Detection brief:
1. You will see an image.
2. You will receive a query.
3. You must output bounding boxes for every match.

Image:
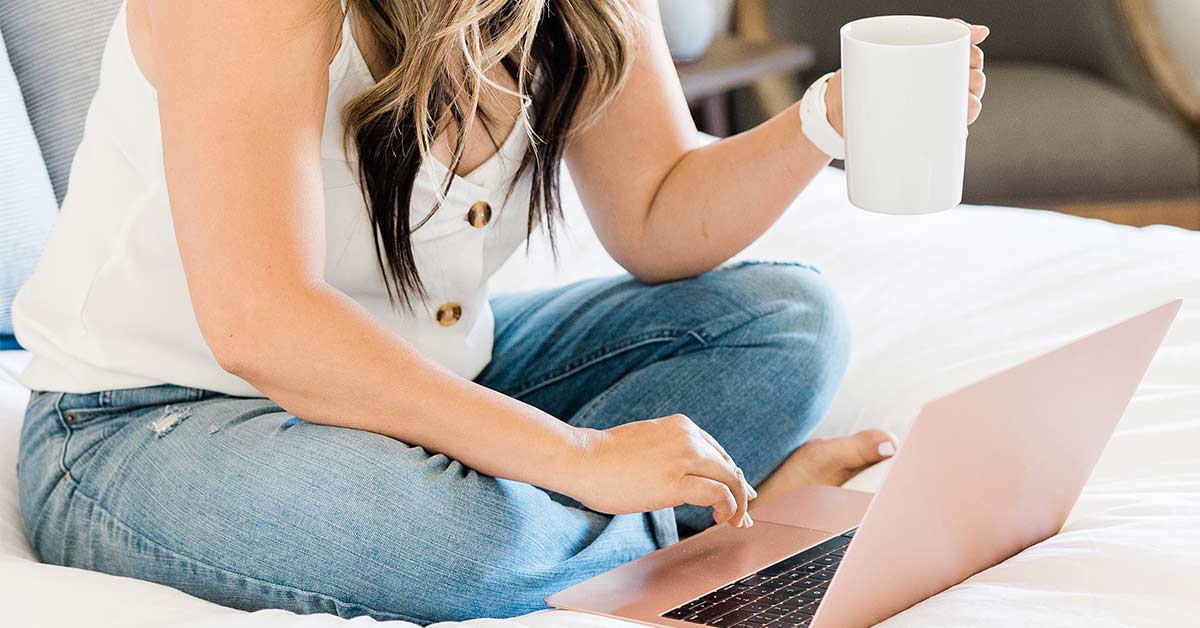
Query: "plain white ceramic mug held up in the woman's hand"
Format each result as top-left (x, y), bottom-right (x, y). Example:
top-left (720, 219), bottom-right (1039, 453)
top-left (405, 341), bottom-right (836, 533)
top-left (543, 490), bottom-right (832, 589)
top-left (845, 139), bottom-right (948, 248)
top-left (841, 16), bottom-right (971, 214)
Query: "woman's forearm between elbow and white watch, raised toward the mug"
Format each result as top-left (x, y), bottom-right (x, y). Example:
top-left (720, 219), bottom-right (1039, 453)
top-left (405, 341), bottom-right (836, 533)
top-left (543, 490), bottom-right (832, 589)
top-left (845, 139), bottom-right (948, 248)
top-left (630, 106), bottom-right (829, 281)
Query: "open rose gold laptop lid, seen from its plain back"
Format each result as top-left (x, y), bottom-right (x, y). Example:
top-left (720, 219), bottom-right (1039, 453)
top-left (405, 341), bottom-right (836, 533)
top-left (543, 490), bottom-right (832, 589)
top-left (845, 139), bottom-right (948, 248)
top-left (812, 300), bottom-right (1182, 628)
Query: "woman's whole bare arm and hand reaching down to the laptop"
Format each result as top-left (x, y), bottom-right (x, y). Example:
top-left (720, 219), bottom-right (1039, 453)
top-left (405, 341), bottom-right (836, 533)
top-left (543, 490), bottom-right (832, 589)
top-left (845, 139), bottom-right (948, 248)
top-left (142, 0), bottom-right (752, 525)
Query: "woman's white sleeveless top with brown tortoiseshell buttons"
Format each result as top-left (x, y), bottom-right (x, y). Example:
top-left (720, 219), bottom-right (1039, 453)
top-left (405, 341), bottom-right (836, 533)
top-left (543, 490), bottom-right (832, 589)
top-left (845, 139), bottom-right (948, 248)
top-left (13, 6), bottom-right (529, 396)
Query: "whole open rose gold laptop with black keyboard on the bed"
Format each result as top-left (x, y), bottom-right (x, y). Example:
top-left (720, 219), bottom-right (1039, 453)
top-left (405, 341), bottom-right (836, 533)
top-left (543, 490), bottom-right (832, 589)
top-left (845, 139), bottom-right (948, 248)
top-left (547, 301), bottom-right (1181, 628)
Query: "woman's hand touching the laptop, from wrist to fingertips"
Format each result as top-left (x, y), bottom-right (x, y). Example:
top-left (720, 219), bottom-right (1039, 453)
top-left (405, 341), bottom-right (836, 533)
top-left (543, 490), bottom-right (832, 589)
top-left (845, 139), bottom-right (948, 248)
top-left (564, 414), bottom-right (757, 527)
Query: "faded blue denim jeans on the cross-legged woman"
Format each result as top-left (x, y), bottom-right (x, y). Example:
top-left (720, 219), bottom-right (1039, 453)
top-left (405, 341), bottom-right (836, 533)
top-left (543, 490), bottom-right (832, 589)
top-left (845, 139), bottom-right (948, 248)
top-left (19, 263), bottom-right (848, 623)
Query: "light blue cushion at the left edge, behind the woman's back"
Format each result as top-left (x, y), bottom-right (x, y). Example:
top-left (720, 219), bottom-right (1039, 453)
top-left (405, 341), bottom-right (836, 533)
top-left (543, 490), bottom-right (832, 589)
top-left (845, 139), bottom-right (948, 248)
top-left (0, 28), bottom-right (58, 348)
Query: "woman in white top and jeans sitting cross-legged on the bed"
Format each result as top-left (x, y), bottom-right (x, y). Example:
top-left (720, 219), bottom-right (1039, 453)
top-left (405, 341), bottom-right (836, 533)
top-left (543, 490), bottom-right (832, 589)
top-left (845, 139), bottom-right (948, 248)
top-left (17, 0), bottom-right (986, 623)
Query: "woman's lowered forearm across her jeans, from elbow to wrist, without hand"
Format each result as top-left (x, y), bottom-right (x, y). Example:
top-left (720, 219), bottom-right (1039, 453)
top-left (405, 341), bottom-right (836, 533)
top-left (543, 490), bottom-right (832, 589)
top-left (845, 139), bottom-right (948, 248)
top-left (222, 285), bottom-right (582, 492)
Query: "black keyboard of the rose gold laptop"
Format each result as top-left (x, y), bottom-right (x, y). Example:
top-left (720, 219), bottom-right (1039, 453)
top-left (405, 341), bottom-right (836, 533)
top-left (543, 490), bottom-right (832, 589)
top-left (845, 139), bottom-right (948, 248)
top-left (662, 528), bottom-right (857, 628)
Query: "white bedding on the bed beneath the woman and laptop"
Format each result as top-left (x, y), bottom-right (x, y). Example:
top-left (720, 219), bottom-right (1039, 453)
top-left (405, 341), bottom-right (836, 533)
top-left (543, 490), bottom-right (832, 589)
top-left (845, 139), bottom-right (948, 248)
top-left (0, 169), bottom-right (1200, 628)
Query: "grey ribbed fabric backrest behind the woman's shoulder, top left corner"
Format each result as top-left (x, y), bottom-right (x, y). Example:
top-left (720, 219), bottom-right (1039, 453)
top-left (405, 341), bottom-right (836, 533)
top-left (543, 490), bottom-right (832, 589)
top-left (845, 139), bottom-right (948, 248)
top-left (0, 0), bottom-right (121, 203)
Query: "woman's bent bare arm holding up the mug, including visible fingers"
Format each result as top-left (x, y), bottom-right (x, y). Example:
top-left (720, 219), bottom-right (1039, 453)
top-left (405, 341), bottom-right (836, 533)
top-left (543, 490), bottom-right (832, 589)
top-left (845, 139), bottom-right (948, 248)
top-left (566, 0), bottom-right (986, 282)
